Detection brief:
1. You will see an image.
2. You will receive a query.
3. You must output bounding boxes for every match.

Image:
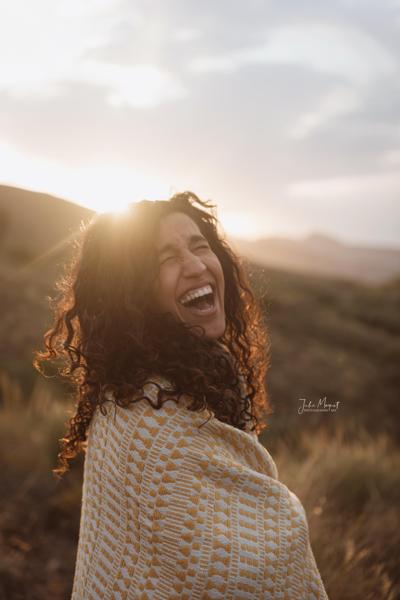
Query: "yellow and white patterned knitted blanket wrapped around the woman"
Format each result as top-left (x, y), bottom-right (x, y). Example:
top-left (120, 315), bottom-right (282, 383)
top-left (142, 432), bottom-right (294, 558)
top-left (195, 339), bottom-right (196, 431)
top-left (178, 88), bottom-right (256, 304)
top-left (71, 378), bottom-right (328, 600)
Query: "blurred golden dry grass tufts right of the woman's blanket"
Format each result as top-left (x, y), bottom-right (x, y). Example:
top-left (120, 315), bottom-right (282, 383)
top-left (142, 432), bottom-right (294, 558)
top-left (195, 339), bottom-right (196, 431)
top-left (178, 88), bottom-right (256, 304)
top-left (276, 430), bottom-right (400, 600)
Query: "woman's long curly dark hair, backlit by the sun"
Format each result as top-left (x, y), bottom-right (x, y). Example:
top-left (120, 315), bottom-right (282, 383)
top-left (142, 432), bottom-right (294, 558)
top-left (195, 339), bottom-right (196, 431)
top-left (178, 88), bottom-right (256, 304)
top-left (33, 191), bottom-right (273, 477)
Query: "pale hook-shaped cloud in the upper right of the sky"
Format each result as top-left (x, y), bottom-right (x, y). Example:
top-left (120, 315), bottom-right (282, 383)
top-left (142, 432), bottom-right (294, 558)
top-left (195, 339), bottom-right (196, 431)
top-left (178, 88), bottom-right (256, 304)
top-left (189, 22), bottom-right (397, 139)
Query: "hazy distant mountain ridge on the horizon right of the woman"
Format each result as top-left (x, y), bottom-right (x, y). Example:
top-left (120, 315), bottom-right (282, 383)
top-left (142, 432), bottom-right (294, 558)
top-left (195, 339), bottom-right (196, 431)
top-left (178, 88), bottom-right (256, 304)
top-left (230, 233), bottom-right (400, 284)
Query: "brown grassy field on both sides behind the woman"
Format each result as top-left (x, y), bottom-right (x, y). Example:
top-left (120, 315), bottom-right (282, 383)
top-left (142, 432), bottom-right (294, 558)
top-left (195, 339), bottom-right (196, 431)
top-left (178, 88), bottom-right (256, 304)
top-left (0, 265), bottom-right (400, 600)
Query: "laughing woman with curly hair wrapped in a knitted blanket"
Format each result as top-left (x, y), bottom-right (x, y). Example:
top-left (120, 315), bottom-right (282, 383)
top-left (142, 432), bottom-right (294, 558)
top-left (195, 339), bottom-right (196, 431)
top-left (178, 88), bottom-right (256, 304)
top-left (35, 192), bottom-right (327, 600)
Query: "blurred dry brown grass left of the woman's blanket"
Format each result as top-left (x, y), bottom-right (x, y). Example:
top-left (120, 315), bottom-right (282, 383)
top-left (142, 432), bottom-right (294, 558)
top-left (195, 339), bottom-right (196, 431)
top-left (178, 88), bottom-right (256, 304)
top-left (0, 372), bottom-right (81, 600)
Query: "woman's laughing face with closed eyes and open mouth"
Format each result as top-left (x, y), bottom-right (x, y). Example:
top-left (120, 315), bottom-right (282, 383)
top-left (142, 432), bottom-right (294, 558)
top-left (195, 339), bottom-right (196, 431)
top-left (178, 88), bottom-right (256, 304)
top-left (154, 212), bottom-right (225, 338)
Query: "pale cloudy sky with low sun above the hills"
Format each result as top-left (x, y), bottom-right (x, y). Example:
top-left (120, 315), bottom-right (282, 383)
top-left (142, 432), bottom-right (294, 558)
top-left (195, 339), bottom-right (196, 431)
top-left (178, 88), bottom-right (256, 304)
top-left (0, 0), bottom-right (400, 247)
